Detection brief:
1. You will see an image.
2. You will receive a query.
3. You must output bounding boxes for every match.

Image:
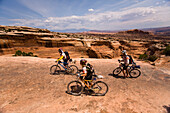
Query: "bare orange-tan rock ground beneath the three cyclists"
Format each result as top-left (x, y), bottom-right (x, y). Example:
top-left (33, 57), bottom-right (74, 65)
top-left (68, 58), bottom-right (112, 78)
top-left (0, 56), bottom-right (170, 113)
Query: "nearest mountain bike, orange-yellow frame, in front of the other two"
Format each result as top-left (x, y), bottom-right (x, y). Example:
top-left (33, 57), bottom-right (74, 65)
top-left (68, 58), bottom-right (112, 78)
top-left (67, 73), bottom-right (108, 96)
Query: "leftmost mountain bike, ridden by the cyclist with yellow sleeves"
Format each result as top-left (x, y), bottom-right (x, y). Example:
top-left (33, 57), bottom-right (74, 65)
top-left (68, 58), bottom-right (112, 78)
top-left (50, 59), bottom-right (78, 75)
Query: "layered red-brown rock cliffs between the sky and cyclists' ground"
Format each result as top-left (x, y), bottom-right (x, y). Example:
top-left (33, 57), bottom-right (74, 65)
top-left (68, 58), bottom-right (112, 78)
top-left (0, 26), bottom-right (169, 58)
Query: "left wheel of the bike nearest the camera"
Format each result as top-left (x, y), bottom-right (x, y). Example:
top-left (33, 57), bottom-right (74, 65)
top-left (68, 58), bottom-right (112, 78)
top-left (67, 81), bottom-right (84, 96)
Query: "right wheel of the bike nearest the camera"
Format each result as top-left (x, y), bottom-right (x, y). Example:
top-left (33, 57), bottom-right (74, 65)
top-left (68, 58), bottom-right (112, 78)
top-left (92, 81), bottom-right (108, 96)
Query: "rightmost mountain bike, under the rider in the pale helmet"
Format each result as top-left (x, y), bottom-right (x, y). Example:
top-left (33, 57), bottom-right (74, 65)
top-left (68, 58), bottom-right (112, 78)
top-left (113, 60), bottom-right (141, 78)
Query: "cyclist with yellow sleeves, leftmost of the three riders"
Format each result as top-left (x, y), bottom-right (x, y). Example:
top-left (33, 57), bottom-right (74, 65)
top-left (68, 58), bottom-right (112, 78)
top-left (56, 49), bottom-right (68, 67)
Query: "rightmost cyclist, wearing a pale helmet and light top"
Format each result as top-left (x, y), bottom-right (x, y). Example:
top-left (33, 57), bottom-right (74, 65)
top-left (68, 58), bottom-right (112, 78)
top-left (118, 50), bottom-right (130, 78)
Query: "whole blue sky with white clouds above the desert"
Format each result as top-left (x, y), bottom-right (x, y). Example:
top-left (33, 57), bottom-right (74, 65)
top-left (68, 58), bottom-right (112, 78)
top-left (0, 0), bottom-right (170, 32)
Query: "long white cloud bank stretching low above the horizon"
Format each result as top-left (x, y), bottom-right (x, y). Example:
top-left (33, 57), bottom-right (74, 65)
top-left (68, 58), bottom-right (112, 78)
top-left (12, 6), bottom-right (170, 30)
